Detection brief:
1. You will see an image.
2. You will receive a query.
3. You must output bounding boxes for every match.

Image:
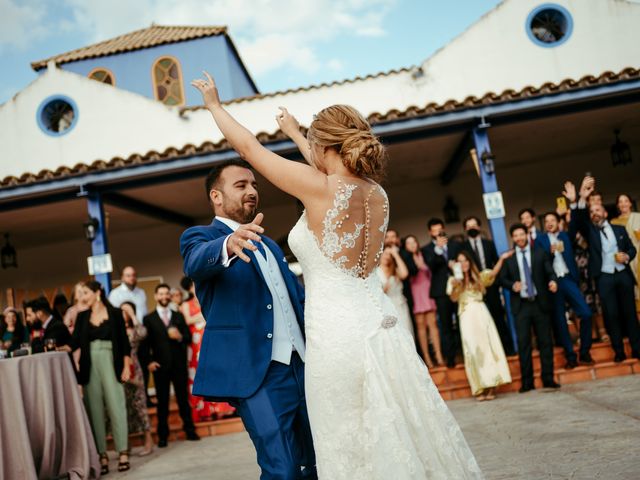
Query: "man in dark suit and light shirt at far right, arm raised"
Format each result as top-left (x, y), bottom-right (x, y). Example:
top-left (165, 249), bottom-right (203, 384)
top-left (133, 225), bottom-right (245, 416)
top-left (563, 177), bottom-right (640, 362)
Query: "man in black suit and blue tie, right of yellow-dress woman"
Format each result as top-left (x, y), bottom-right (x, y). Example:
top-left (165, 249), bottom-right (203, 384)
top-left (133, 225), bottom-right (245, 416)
top-left (500, 223), bottom-right (560, 393)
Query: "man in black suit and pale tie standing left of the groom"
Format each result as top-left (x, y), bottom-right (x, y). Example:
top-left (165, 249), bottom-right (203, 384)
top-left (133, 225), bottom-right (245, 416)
top-left (141, 283), bottom-right (200, 447)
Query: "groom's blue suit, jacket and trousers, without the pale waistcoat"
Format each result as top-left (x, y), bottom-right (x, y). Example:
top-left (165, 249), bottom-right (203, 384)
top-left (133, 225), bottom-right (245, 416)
top-left (180, 220), bottom-right (315, 479)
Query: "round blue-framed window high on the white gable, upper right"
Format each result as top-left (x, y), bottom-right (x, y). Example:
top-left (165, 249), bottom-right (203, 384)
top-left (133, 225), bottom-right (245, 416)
top-left (526, 4), bottom-right (573, 47)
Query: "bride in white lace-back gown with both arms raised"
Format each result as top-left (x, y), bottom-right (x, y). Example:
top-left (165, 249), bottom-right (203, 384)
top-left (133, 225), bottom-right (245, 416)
top-left (192, 72), bottom-right (483, 480)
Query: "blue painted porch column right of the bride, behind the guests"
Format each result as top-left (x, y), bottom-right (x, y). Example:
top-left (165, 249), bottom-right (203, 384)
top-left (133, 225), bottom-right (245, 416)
top-left (473, 124), bottom-right (518, 352)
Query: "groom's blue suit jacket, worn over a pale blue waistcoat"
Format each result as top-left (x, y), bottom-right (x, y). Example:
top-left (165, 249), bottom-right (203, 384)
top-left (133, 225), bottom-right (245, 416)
top-left (180, 220), bottom-right (304, 399)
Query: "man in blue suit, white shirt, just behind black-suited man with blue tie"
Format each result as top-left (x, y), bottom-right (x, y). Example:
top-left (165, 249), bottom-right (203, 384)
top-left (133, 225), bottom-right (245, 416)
top-left (536, 212), bottom-right (593, 368)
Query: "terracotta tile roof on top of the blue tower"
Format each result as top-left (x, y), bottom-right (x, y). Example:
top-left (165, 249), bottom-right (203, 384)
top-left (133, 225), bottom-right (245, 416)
top-left (31, 25), bottom-right (227, 70)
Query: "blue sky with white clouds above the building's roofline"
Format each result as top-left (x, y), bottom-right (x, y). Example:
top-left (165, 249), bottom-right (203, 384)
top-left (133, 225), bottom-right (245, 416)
top-left (0, 0), bottom-right (500, 104)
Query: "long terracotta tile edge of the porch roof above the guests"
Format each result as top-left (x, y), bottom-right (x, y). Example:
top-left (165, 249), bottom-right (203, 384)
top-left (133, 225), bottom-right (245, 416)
top-left (0, 68), bottom-right (640, 188)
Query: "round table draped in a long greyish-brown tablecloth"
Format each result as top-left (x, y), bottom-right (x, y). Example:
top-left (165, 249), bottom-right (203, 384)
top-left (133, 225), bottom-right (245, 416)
top-left (0, 352), bottom-right (100, 480)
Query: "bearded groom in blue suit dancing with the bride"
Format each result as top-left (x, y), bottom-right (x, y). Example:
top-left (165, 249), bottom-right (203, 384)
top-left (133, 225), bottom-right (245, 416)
top-left (180, 160), bottom-right (317, 480)
